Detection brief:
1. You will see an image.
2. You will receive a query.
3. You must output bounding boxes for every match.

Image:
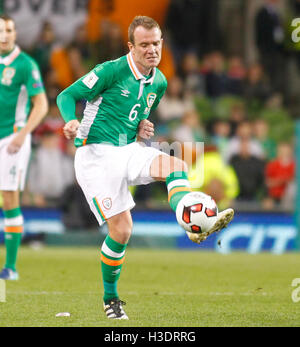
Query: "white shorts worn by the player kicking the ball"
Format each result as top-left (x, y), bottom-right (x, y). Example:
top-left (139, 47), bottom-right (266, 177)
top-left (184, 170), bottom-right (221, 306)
top-left (75, 142), bottom-right (164, 225)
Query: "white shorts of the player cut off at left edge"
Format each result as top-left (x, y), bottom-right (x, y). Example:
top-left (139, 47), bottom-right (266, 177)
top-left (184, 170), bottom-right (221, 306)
top-left (0, 133), bottom-right (31, 191)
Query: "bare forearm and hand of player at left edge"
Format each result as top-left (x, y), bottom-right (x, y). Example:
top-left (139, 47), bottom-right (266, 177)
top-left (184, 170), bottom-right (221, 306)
top-left (7, 93), bottom-right (48, 154)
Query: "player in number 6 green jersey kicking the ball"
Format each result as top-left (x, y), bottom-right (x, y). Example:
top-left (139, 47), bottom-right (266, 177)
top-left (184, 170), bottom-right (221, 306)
top-left (57, 16), bottom-right (233, 319)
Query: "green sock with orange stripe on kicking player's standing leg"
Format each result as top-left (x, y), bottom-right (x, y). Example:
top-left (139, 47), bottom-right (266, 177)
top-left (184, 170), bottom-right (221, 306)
top-left (101, 235), bottom-right (127, 303)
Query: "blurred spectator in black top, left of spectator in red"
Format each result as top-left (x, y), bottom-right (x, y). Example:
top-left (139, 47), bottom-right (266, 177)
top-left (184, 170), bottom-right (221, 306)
top-left (229, 138), bottom-right (265, 203)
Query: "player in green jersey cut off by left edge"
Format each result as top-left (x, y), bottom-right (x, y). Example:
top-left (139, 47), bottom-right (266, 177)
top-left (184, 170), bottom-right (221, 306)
top-left (0, 15), bottom-right (48, 280)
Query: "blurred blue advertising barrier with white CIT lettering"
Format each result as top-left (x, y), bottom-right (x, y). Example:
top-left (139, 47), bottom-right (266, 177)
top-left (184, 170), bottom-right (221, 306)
top-left (0, 208), bottom-right (299, 254)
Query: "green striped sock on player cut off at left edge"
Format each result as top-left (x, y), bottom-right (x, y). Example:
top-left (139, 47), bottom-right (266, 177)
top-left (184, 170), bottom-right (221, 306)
top-left (3, 207), bottom-right (24, 271)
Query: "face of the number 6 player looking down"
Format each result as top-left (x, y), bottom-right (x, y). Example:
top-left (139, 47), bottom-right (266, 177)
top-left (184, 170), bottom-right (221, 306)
top-left (128, 26), bottom-right (163, 75)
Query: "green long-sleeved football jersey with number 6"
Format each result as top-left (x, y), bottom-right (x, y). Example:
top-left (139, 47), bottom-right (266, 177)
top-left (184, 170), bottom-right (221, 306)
top-left (58, 53), bottom-right (167, 147)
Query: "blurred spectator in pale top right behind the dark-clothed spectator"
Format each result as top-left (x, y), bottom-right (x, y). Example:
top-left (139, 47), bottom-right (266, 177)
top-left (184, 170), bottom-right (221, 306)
top-left (225, 121), bottom-right (264, 162)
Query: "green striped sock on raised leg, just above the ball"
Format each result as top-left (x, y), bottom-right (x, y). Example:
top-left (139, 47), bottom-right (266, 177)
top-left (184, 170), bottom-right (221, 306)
top-left (166, 171), bottom-right (191, 212)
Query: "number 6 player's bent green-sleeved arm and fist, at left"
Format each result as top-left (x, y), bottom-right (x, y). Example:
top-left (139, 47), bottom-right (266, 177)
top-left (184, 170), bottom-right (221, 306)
top-left (57, 64), bottom-right (113, 139)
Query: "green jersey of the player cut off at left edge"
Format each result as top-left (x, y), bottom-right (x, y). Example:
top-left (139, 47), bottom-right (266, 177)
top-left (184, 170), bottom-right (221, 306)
top-left (0, 46), bottom-right (44, 139)
